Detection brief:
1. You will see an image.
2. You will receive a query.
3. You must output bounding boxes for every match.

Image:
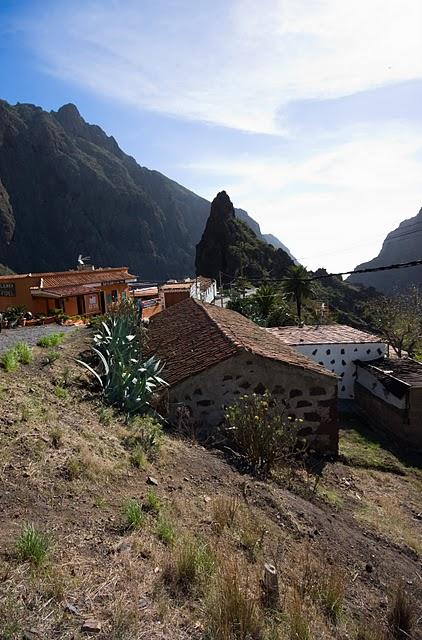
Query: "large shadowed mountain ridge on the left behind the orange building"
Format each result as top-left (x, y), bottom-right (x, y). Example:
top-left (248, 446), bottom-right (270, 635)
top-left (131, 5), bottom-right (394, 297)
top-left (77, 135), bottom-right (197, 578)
top-left (0, 101), bottom-right (286, 279)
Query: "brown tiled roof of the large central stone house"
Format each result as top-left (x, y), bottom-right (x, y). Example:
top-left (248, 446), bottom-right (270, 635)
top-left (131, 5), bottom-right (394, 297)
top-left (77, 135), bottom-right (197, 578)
top-left (148, 298), bottom-right (335, 384)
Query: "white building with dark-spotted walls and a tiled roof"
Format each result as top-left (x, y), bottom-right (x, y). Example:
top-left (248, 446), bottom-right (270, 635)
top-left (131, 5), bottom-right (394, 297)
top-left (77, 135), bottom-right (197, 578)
top-left (268, 324), bottom-right (387, 400)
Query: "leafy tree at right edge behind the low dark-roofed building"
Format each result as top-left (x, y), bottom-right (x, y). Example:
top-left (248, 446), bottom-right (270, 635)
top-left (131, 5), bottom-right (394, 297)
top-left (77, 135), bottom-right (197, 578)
top-left (365, 286), bottom-right (422, 358)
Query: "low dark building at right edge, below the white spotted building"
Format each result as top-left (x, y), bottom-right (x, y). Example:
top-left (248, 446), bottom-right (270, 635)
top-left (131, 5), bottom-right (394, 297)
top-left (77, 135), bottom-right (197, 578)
top-left (355, 358), bottom-right (422, 451)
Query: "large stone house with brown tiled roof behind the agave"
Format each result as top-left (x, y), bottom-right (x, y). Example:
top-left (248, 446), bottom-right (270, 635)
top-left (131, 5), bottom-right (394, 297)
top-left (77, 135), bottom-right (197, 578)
top-left (148, 298), bottom-right (338, 453)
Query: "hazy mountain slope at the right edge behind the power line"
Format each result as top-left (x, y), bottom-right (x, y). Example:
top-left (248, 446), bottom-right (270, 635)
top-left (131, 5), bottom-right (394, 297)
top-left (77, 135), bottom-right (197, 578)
top-left (347, 209), bottom-right (422, 293)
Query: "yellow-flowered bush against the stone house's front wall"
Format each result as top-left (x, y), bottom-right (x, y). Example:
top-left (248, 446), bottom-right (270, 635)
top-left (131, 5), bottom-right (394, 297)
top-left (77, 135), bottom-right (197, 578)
top-left (225, 392), bottom-right (300, 477)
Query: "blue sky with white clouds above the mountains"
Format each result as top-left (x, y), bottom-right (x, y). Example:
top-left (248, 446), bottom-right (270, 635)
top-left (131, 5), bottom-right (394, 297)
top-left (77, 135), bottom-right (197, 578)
top-left (0, 0), bottom-right (422, 271)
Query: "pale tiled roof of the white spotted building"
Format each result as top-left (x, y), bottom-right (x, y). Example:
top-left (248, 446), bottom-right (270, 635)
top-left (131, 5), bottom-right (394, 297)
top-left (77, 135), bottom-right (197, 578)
top-left (267, 324), bottom-right (384, 346)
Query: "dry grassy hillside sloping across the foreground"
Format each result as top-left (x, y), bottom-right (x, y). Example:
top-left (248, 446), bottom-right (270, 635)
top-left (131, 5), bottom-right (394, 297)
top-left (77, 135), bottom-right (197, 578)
top-left (0, 330), bottom-right (422, 640)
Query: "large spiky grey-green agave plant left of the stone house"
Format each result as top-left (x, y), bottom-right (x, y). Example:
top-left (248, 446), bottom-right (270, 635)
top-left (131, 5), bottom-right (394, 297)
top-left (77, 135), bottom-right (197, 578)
top-left (78, 305), bottom-right (167, 415)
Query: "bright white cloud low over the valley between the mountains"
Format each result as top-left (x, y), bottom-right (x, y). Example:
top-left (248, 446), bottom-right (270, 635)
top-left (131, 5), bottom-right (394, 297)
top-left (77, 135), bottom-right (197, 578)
top-left (184, 125), bottom-right (422, 271)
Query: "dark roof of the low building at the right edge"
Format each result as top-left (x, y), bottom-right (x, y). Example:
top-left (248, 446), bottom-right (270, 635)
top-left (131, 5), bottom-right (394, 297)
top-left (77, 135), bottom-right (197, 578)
top-left (357, 358), bottom-right (422, 395)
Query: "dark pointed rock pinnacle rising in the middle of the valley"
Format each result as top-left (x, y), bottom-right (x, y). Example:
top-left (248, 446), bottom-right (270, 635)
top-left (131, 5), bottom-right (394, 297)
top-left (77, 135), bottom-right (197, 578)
top-left (195, 191), bottom-right (292, 281)
